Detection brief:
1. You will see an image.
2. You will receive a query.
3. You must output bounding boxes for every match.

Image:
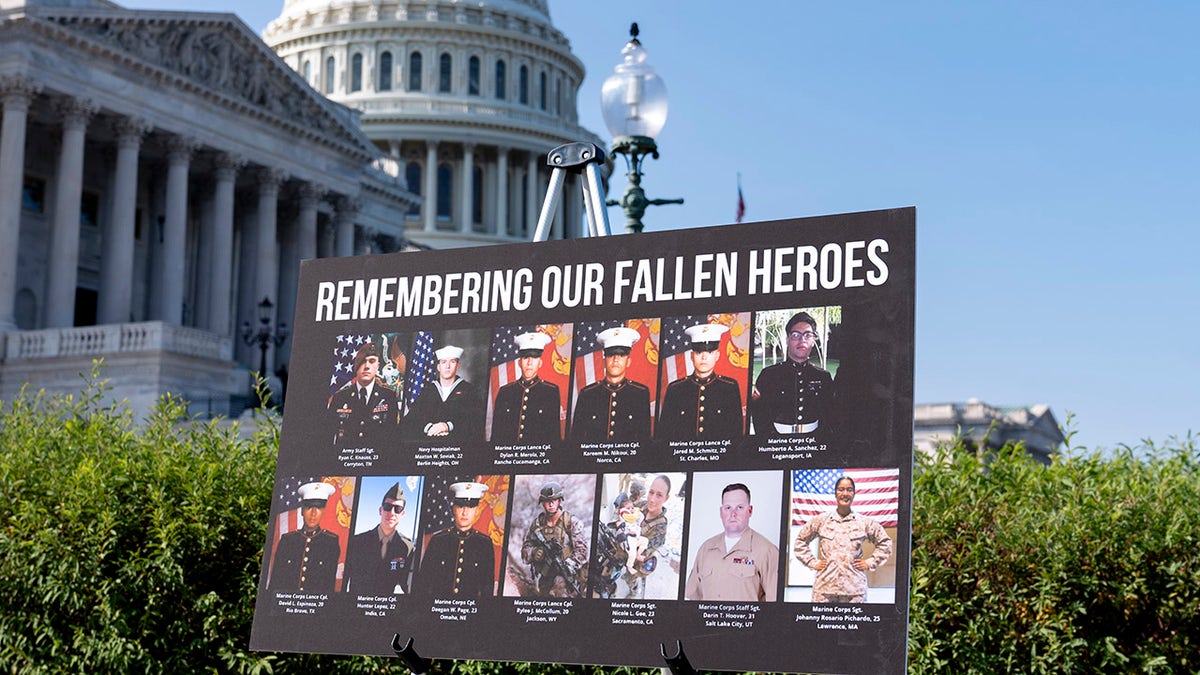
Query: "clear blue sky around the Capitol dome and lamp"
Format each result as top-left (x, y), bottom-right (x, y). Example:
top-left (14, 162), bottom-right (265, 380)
top-left (124, 0), bottom-right (1200, 448)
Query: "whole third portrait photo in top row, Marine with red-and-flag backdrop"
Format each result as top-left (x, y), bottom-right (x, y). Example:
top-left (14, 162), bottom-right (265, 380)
top-left (488, 327), bottom-right (570, 446)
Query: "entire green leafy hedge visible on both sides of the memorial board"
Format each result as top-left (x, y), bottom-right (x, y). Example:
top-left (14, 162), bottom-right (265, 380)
top-left (0, 370), bottom-right (1200, 675)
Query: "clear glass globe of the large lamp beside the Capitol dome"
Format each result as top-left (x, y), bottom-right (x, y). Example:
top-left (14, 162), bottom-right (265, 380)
top-left (600, 34), bottom-right (667, 138)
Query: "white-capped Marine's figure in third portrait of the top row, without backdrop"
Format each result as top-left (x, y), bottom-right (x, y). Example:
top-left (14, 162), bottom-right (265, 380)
top-left (492, 333), bottom-right (563, 444)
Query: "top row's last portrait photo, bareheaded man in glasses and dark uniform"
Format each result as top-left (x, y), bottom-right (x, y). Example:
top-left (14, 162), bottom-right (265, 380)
top-left (750, 307), bottom-right (841, 440)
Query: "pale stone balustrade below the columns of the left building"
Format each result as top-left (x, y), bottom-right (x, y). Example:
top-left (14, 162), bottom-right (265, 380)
top-left (5, 321), bottom-right (233, 360)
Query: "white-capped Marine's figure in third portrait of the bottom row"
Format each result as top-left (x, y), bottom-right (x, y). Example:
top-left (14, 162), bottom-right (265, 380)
top-left (416, 482), bottom-right (496, 598)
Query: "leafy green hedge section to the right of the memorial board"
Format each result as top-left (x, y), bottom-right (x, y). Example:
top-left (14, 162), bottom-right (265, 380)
top-left (908, 437), bottom-right (1200, 673)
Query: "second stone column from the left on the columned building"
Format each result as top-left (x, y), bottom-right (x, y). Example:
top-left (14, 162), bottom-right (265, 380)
top-left (46, 98), bottom-right (96, 328)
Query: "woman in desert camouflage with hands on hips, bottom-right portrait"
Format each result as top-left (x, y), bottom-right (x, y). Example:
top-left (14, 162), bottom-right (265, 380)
top-left (793, 476), bottom-right (892, 603)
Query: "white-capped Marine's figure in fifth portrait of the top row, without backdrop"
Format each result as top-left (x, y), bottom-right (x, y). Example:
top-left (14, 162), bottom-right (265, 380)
top-left (654, 323), bottom-right (742, 441)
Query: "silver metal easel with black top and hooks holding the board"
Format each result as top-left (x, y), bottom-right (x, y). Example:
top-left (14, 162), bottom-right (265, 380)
top-left (391, 143), bottom-right (696, 675)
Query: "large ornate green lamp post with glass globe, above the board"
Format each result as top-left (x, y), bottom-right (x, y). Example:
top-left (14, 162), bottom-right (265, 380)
top-left (600, 23), bottom-right (683, 232)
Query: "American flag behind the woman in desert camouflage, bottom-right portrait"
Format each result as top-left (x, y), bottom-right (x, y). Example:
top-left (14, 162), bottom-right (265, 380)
top-left (792, 468), bottom-right (900, 527)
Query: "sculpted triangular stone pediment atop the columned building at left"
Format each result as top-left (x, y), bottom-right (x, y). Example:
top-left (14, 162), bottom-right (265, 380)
top-left (30, 10), bottom-right (376, 157)
